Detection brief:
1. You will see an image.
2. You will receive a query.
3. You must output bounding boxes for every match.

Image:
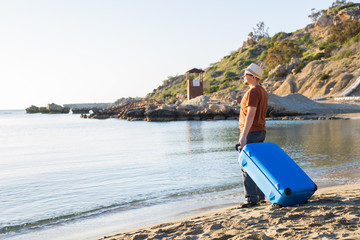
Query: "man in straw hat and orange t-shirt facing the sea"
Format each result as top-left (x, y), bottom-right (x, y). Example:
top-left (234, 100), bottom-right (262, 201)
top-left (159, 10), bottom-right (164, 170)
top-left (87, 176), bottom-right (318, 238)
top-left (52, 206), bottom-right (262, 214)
top-left (238, 63), bottom-right (268, 208)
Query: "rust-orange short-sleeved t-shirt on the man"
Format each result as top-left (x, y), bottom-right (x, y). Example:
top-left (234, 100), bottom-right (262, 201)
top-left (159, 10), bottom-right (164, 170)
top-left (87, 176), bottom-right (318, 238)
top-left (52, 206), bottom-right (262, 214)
top-left (239, 85), bottom-right (269, 132)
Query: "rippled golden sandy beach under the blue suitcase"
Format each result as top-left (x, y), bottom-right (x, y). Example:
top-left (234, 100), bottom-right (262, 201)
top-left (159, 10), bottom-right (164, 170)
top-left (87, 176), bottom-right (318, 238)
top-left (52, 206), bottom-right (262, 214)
top-left (100, 184), bottom-right (360, 240)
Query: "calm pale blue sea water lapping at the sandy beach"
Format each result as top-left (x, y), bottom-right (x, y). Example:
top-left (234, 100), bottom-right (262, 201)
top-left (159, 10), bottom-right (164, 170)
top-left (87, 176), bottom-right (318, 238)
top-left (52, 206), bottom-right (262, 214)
top-left (0, 111), bottom-right (360, 239)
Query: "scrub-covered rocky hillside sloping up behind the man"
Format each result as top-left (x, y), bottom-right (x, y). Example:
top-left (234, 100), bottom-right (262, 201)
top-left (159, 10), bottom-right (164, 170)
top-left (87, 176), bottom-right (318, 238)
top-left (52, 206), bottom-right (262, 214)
top-left (145, 0), bottom-right (360, 103)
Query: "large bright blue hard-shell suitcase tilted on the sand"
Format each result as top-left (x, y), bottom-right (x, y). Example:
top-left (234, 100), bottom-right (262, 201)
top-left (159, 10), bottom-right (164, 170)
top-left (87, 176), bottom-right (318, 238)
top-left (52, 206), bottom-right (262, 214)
top-left (239, 143), bottom-right (317, 206)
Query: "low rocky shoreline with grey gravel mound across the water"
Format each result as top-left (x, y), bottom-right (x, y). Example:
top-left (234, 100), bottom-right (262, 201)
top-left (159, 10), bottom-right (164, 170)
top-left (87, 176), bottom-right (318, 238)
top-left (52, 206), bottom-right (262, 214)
top-left (26, 93), bottom-right (360, 122)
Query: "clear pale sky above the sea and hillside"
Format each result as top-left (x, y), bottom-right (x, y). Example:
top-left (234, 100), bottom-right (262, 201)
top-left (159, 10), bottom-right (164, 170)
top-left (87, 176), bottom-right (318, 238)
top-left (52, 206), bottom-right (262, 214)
top-left (0, 0), bottom-right (348, 109)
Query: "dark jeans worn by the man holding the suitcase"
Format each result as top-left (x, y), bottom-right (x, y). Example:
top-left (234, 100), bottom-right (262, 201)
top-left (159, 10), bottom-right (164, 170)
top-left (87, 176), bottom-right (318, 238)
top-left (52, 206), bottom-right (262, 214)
top-left (241, 131), bottom-right (266, 202)
